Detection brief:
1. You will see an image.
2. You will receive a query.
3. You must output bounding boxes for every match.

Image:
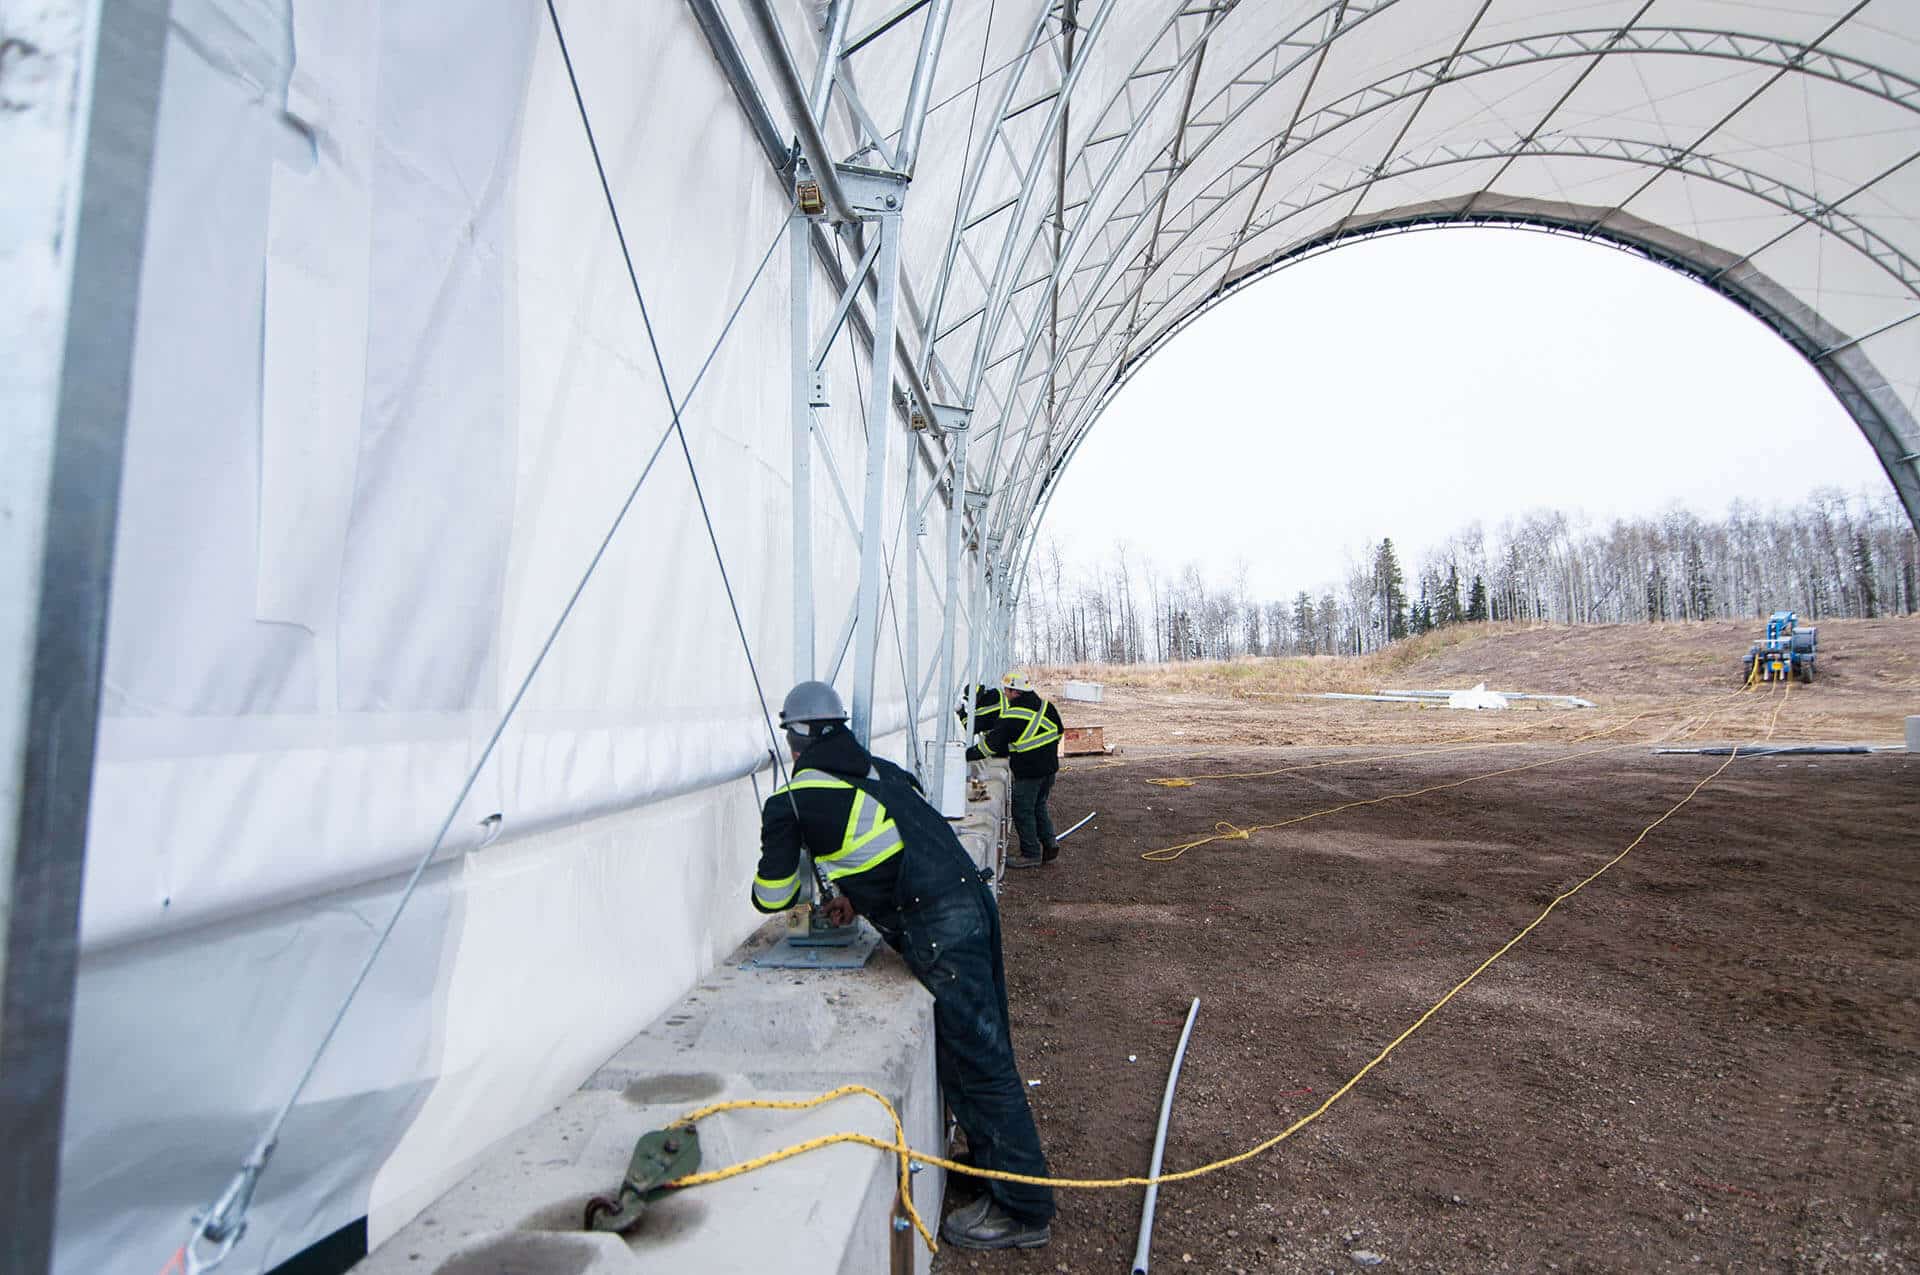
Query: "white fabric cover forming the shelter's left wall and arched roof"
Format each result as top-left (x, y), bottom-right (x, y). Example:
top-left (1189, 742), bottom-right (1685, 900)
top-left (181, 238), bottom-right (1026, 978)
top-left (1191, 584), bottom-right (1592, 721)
top-left (45, 0), bottom-right (1920, 1275)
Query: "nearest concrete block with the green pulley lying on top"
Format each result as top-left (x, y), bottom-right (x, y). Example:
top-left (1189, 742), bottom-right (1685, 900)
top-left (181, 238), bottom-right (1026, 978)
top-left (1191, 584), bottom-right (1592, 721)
top-left (355, 918), bottom-right (945, 1275)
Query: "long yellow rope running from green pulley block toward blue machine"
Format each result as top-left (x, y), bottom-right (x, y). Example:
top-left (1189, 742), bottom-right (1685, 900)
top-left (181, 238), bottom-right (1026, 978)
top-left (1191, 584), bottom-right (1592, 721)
top-left (670, 718), bottom-right (1766, 1252)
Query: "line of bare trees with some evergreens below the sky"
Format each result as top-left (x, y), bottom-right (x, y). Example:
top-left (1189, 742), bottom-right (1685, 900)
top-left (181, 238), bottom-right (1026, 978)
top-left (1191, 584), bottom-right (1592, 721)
top-left (1016, 490), bottom-right (1920, 664)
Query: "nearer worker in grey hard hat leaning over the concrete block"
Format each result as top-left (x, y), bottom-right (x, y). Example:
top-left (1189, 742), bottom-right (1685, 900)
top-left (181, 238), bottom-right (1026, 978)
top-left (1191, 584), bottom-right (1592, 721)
top-left (753, 682), bottom-right (1054, 1248)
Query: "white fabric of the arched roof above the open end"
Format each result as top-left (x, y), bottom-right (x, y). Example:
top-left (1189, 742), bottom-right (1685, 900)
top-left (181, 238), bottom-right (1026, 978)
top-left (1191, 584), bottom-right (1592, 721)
top-left (787, 0), bottom-right (1920, 580)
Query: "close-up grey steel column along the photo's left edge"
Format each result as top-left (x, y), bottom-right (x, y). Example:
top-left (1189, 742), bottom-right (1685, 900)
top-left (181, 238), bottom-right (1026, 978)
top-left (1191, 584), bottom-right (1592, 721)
top-left (0, 0), bottom-right (169, 1275)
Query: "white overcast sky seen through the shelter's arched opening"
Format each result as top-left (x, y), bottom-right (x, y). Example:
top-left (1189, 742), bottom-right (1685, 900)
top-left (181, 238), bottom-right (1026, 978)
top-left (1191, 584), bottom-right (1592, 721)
top-left (1041, 229), bottom-right (1889, 597)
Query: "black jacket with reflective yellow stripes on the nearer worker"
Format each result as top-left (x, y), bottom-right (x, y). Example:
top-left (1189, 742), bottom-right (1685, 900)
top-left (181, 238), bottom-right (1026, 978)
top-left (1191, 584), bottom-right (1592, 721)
top-left (753, 730), bottom-right (979, 939)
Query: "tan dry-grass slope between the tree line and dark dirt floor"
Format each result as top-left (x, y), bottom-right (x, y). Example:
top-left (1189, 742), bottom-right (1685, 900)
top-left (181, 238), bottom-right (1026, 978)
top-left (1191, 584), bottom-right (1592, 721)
top-left (1035, 616), bottom-right (1920, 749)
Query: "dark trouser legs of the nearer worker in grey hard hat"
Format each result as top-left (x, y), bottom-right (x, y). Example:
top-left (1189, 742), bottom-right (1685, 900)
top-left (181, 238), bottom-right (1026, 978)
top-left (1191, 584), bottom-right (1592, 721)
top-left (900, 883), bottom-right (1054, 1221)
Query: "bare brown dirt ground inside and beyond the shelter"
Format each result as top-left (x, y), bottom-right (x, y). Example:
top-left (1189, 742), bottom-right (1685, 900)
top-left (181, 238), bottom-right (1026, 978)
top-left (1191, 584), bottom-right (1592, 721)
top-left (935, 622), bottom-right (1920, 1273)
